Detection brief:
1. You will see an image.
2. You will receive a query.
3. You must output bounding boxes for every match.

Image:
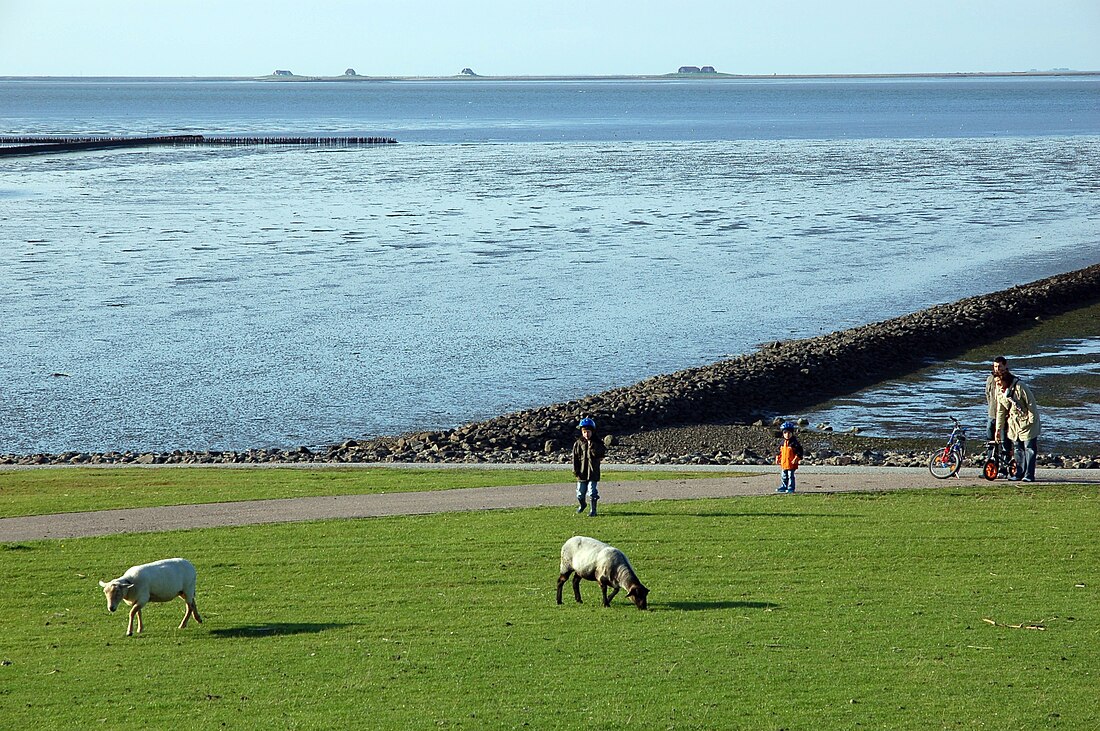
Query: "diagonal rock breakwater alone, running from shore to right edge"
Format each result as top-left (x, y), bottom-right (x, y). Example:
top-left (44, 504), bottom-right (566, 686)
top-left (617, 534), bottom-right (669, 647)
top-left (327, 264), bottom-right (1100, 464)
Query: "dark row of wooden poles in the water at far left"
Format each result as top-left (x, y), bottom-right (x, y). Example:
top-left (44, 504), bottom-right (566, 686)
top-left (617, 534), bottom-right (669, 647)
top-left (0, 134), bottom-right (397, 156)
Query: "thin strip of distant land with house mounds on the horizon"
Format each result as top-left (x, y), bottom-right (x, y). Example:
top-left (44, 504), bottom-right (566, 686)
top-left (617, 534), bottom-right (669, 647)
top-left (0, 68), bottom-right (1100, 82)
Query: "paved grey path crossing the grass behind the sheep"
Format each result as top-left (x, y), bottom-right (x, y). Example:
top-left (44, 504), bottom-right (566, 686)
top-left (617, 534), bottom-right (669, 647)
top-left (0, 466), bottom-right (1100, 542)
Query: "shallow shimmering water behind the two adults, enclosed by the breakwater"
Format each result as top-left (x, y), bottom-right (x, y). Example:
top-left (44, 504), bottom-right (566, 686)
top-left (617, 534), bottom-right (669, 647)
top-left (806, 307), bottom-right (1100, 452)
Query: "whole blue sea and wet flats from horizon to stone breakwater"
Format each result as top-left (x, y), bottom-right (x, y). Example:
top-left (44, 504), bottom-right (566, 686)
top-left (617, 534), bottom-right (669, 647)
top-left (0, 78), bottom-right (1100, 453)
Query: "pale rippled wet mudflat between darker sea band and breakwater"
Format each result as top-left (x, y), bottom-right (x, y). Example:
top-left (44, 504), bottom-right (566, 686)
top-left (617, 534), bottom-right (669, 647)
top-left (0, 137), bottom-right (1100, 452)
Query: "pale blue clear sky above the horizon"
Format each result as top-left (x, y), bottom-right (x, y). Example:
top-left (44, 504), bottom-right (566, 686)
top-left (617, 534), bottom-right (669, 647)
top-left (0, 0), bottom-right (1100, 77)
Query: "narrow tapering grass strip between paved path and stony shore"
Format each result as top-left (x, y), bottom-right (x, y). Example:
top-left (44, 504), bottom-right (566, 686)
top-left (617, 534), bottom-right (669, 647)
top-left (0, 467), bottom-right (738, 518)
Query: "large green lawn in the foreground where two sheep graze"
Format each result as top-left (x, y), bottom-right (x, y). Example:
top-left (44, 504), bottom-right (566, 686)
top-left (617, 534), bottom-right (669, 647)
top-left (0, 485), bottom-right (1100, 730)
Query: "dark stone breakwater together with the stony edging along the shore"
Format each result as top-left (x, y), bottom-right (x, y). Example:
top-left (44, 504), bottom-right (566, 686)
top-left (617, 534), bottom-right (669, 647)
top-left (0, 264), bottom-right (1100, 467)
